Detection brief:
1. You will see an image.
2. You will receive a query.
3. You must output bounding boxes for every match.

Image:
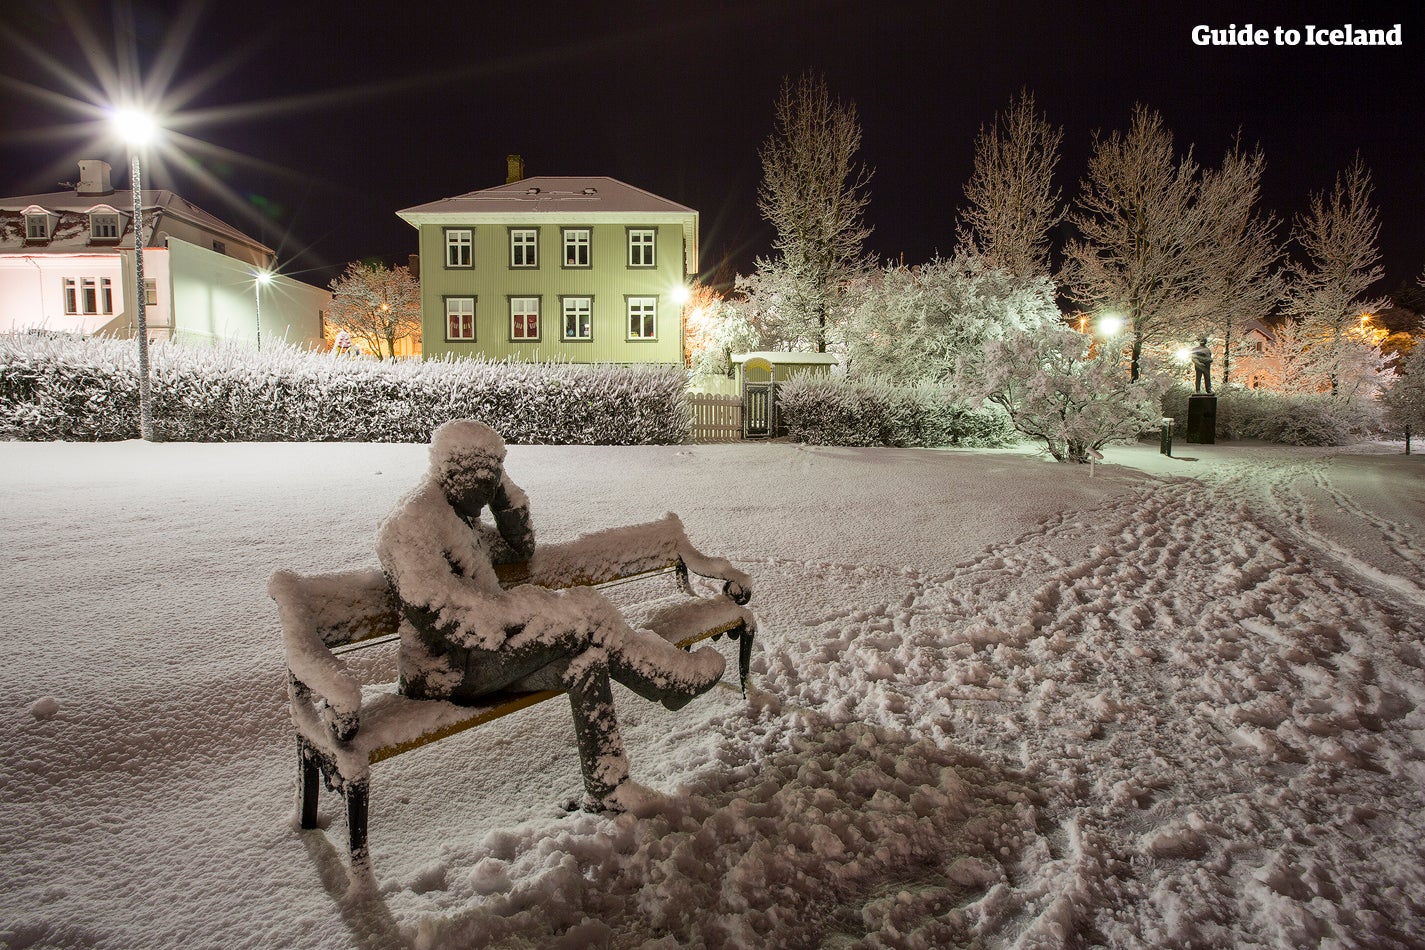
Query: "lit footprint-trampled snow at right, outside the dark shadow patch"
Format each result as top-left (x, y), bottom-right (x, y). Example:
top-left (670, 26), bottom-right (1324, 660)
top-left (768, 459), bottom-right (1425, 947)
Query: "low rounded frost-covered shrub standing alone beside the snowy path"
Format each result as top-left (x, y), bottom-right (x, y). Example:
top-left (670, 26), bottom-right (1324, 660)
top-left (956, 323), bottom-right (1164, 461)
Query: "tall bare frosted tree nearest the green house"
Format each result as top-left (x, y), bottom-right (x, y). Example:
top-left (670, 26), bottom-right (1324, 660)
top-left (757, 73), bottom-right (871, 352)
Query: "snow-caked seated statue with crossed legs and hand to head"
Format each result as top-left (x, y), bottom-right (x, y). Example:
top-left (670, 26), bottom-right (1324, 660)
top-left (376, 420), bottom-right (724, 810)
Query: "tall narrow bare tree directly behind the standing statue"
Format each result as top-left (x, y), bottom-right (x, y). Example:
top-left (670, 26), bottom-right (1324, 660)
top-left (1200, 140), bottom-right (1283, 389)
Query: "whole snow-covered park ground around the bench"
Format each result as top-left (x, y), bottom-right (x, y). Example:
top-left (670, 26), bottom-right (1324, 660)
top-left (0, 443), bottom-right (1425, 949)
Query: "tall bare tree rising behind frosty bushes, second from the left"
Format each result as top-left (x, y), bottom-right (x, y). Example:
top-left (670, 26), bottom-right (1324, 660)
top-left (959, 90), bottom-right (1066, 276)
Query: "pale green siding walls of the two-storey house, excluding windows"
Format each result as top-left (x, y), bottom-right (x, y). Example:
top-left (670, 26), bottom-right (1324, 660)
top-left (420, 219), bottom-right (684, 363)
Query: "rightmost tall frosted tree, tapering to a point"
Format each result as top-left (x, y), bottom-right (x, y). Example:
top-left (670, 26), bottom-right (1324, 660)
top-left (1284, 155), bottom-right (1387, 397)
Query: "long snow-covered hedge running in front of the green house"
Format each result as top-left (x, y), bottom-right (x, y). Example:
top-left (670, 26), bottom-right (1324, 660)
top-left (0, 333), bottom-right (688, 444)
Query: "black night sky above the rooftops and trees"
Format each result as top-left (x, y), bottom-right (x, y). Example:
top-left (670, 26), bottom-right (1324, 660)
top-left (0, 0), bottom-right (1425, 297)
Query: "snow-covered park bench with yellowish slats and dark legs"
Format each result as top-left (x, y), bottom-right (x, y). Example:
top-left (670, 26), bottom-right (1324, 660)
top-left (268, 516), bottom-right (757, 867)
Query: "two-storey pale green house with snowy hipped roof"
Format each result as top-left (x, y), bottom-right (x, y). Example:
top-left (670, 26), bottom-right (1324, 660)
top-left (396, 170), bottom-right (698, 365)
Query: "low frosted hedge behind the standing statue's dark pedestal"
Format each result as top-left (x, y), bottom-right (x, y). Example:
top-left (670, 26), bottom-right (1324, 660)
top-left (1163, 385), bottom-right (1379, 446)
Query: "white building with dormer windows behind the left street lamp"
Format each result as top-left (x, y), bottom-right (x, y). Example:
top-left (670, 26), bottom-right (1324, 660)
top-left (0, 161), bottom-right (332, 348)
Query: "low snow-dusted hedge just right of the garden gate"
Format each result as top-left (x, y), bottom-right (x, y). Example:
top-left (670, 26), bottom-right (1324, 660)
top-left (777, 376), bottom-right (1019, 447)
